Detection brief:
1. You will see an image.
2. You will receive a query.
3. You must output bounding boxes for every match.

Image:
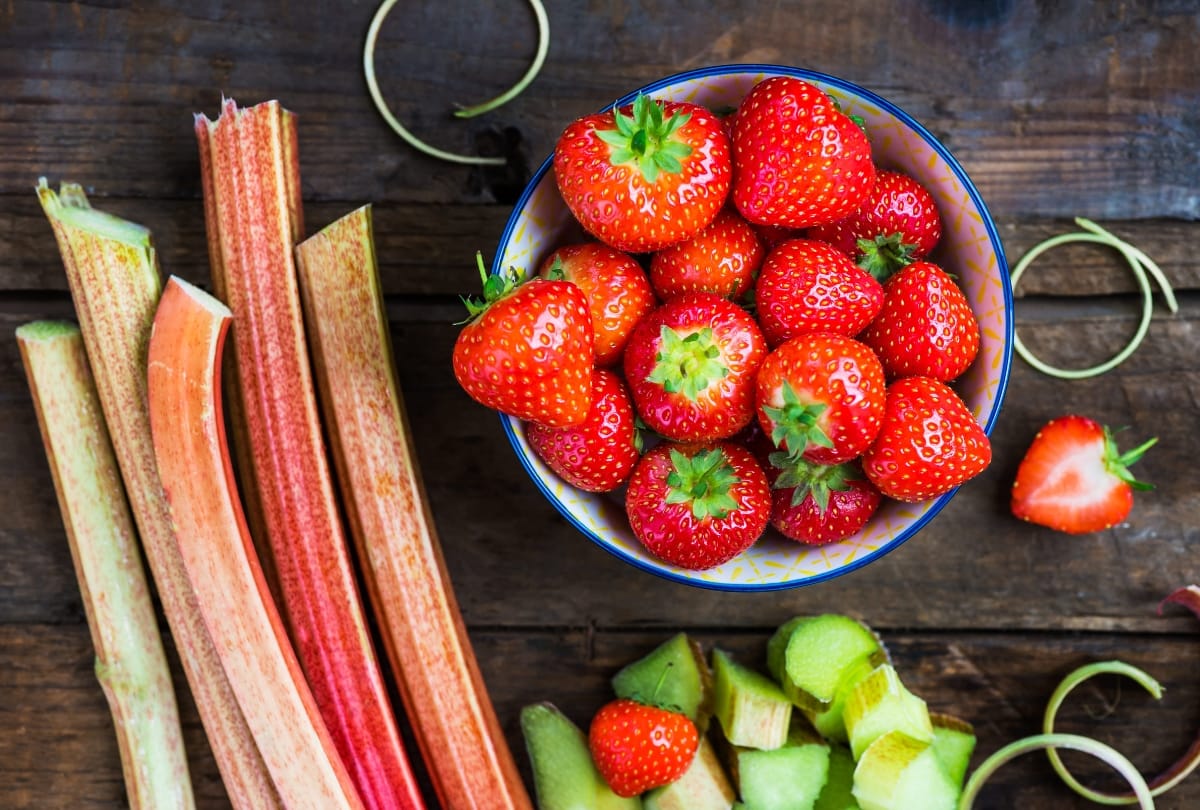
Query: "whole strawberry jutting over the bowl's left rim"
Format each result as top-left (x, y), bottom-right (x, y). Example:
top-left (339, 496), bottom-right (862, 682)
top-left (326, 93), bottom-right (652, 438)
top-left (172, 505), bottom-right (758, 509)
top-left (452, 257), bottom-right (593, 427)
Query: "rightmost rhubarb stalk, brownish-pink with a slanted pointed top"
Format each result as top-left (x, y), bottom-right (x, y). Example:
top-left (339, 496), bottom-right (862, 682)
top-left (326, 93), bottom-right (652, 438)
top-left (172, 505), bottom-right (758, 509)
top-left (296, 206), bottom-right (532, 810)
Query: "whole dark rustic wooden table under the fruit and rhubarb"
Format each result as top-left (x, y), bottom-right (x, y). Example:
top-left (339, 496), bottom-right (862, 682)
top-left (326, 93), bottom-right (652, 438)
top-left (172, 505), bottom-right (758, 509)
top-left (0, 0), bottom-right (1200, 809)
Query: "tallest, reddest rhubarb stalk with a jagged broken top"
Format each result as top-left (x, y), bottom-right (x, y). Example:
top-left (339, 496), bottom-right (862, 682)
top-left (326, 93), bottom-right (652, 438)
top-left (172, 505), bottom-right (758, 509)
top-left (196, 101), bottom-right (424, 810)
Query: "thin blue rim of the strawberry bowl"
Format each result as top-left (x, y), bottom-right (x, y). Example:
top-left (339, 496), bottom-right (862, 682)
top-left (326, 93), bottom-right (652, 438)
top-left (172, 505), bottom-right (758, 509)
top-left (491, 62), bottom-right (1015, 593)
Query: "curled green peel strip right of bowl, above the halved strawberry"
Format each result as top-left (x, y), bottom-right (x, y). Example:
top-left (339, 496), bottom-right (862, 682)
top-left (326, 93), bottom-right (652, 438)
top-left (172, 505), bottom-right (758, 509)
top-left (1010, 217), bottom-right (1180, 379)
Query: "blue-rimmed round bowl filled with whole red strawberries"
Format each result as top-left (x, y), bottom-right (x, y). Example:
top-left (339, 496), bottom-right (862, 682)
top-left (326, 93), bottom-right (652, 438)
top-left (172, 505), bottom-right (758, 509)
top-left (454, 65), bottom-right (1013, 590)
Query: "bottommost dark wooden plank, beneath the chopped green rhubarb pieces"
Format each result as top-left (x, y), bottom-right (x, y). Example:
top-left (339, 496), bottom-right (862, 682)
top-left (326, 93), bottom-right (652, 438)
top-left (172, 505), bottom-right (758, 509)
top-left (0, 624), bottom-right (1200, 810)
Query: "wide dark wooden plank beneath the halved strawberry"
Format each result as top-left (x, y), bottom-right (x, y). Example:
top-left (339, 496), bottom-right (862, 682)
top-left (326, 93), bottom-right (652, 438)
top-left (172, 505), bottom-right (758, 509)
top-left (0, 300), bottom-right (1200, 632)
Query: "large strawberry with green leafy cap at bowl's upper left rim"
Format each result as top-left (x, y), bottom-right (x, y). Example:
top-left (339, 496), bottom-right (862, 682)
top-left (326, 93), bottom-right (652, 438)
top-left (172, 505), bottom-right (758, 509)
top-left (554, 96), bottom-right (732, 253)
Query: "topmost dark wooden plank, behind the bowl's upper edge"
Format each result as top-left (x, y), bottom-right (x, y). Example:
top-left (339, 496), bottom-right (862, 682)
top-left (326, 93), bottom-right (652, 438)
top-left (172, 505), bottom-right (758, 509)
top-left (0, 0), bottom-right (1200, 220)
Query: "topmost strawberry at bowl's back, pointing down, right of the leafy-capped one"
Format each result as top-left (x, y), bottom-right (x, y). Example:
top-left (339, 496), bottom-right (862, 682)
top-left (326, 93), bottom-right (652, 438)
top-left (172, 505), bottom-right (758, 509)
top-left (733, 76), bottom-right (875, 228)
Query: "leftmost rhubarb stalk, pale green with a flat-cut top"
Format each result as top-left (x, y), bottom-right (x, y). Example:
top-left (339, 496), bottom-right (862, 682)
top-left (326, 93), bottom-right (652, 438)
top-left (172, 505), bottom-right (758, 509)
top-left (17, 320), bottom-right (196, 810)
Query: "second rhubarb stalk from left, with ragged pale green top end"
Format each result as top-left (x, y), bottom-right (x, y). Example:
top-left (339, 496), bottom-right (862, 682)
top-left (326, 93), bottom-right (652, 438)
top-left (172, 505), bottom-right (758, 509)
top-left (37, 179), bottom-right (278, 810)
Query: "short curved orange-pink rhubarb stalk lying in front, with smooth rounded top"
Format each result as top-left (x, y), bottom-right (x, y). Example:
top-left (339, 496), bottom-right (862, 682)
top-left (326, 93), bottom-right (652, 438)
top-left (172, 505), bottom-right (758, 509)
top-left (146, 277), bottom-right (362, 810)
